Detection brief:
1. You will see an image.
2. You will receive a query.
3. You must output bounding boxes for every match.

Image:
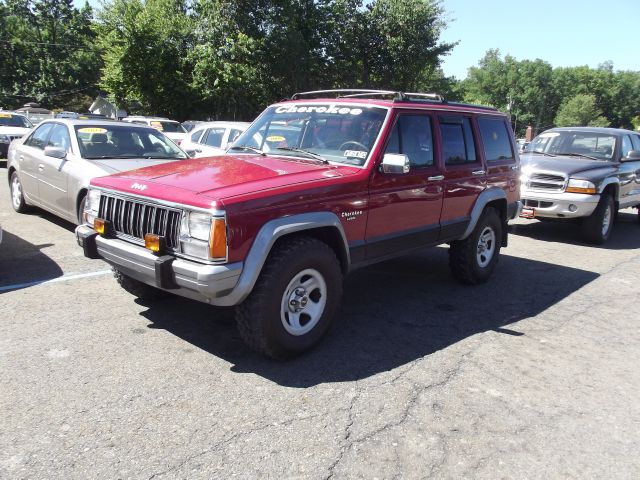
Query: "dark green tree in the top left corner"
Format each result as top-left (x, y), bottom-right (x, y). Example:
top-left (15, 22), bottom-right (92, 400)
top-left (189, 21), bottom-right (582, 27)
top-left (0, 0), bottom-right (101, 108)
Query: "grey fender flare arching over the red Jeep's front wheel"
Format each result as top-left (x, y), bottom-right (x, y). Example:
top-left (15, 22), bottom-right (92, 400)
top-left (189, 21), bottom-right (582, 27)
top-left (216, 212), bottom-right (351, 305)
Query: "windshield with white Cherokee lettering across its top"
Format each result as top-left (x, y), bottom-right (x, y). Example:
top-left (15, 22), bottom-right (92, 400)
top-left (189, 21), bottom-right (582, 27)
top-left (229, 103), bottom-right (387, 166)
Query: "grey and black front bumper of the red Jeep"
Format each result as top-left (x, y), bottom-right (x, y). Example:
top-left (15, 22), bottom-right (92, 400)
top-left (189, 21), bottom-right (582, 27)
top-left (76, 225), bottom-right (243, 306)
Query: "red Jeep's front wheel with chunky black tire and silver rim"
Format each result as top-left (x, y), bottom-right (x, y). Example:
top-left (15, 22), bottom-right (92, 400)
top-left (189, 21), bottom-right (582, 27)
top-left (236, 237), bottom-right (343, 359)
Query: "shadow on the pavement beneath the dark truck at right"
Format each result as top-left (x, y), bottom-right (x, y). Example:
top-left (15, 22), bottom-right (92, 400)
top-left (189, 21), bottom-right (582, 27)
top-left (509, 209), bottom-right (640, 250)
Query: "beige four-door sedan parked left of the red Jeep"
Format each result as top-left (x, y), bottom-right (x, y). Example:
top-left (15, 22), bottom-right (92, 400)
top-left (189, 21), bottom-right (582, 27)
top-left (7, 119), bottom-right (188, 222)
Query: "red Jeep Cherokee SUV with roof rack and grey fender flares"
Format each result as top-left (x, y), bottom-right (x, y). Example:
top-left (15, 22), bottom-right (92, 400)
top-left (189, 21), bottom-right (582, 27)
top-left (76, 90), bottom-right (521, 357)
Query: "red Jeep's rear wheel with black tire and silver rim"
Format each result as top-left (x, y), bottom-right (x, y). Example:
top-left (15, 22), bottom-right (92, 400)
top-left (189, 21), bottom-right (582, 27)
top-left (449, 207), bottom-right (502, 285)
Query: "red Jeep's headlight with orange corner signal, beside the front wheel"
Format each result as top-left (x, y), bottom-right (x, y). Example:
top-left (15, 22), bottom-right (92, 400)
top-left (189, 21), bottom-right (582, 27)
top-left (180, 212), bottom-right (227, 261)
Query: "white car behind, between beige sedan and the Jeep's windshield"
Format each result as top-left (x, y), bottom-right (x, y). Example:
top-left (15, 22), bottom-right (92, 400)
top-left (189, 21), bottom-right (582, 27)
top-left (180, 122), bottom-right (250, 157)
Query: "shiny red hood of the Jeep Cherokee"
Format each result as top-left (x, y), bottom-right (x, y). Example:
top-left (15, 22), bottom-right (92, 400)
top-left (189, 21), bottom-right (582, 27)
top-left (91, 155), bottom-right (361, 208)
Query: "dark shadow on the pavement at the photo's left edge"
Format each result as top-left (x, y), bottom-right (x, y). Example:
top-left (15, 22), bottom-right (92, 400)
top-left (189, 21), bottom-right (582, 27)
top-left (0, 230), bottom-right (63, 294)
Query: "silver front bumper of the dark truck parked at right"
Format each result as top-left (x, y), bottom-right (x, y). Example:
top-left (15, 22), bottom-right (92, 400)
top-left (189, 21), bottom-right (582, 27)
top-left (520, 189), bottom-right (600, 218)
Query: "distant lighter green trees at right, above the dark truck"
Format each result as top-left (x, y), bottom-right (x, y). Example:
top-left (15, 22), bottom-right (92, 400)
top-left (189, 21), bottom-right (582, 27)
top-left (462, 50), bottom-right (640, 135)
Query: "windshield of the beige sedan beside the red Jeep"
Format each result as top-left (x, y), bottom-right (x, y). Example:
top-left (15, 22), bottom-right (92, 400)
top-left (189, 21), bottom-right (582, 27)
top-left (75, 122), bottom-right (188, 159)
